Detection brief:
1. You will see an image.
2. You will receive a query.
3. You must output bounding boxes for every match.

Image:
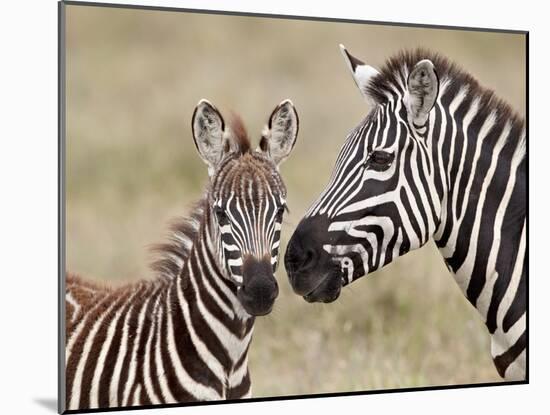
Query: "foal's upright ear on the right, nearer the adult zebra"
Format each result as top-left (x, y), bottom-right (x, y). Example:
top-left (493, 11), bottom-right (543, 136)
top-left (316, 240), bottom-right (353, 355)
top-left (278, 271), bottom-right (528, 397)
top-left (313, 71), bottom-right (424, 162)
top-left (259, 99), bottom-right (299, 166)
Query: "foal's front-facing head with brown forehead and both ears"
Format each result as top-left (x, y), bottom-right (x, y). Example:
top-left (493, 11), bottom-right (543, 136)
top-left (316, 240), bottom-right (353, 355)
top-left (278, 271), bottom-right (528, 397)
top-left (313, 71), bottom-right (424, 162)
top-left (192, 100), bottom-right (298, 315)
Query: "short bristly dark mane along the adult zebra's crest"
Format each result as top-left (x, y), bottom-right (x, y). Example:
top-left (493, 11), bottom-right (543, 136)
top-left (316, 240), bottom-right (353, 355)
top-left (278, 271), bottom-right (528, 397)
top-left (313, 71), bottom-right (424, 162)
top-left (367, 48), bottom-right (524, 143)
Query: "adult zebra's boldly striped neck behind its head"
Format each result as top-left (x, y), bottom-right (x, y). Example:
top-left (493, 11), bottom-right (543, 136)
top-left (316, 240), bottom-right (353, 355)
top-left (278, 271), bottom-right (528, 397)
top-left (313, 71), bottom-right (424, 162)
top-left (429, 80), bottom-right (526, 306)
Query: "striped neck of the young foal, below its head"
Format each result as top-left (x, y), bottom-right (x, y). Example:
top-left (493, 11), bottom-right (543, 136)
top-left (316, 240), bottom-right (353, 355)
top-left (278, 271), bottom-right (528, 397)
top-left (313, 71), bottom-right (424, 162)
top-left (163, 214), bottom-right (254, 397)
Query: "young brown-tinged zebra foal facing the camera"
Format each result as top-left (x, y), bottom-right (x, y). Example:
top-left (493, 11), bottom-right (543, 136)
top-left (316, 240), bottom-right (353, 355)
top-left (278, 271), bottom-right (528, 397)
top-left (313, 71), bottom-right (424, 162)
top-left (66, 100), bottom-right (298, 409)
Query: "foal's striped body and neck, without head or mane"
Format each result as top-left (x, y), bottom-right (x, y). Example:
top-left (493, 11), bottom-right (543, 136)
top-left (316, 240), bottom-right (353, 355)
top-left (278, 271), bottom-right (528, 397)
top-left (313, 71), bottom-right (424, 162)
top-left (66, 228), bottom-right (254, 409)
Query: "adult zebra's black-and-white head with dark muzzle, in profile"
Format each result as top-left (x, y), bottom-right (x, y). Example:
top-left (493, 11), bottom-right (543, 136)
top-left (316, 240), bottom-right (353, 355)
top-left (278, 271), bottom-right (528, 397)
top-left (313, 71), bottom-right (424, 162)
top-left (285, 46), bottom-right (440, 302)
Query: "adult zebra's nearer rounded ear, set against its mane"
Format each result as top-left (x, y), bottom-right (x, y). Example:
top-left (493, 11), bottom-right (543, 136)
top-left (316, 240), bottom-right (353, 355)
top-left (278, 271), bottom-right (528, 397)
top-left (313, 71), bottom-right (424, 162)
top-left (404, 59), bottom-right (439, 127)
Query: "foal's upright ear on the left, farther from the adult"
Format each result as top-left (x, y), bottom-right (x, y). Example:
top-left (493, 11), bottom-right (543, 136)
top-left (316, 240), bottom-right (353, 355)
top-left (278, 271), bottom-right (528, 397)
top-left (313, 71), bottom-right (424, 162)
top-left (191, 99), bottom-right (225, 174)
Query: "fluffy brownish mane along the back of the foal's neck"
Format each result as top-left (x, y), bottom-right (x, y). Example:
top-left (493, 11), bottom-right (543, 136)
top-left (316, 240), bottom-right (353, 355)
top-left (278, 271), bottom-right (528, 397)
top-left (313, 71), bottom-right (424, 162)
top-left (151, 196), bottom-right (206, 278)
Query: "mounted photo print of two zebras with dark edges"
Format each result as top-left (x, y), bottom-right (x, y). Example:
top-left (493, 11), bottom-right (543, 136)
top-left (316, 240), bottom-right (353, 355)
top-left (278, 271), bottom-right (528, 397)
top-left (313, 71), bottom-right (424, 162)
top-left (59, 2), bottom-right (528, 412)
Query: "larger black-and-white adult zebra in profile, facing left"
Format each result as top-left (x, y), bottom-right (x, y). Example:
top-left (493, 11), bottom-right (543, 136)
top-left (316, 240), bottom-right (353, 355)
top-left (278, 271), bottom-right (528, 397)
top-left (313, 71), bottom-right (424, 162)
top-left (285, 46), bottom-right (527, 379)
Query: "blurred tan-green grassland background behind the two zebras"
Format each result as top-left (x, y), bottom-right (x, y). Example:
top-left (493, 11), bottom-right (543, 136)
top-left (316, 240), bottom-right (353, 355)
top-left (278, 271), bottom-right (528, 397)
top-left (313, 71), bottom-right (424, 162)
top-left (66, 5), bottom-right (526, 396)
